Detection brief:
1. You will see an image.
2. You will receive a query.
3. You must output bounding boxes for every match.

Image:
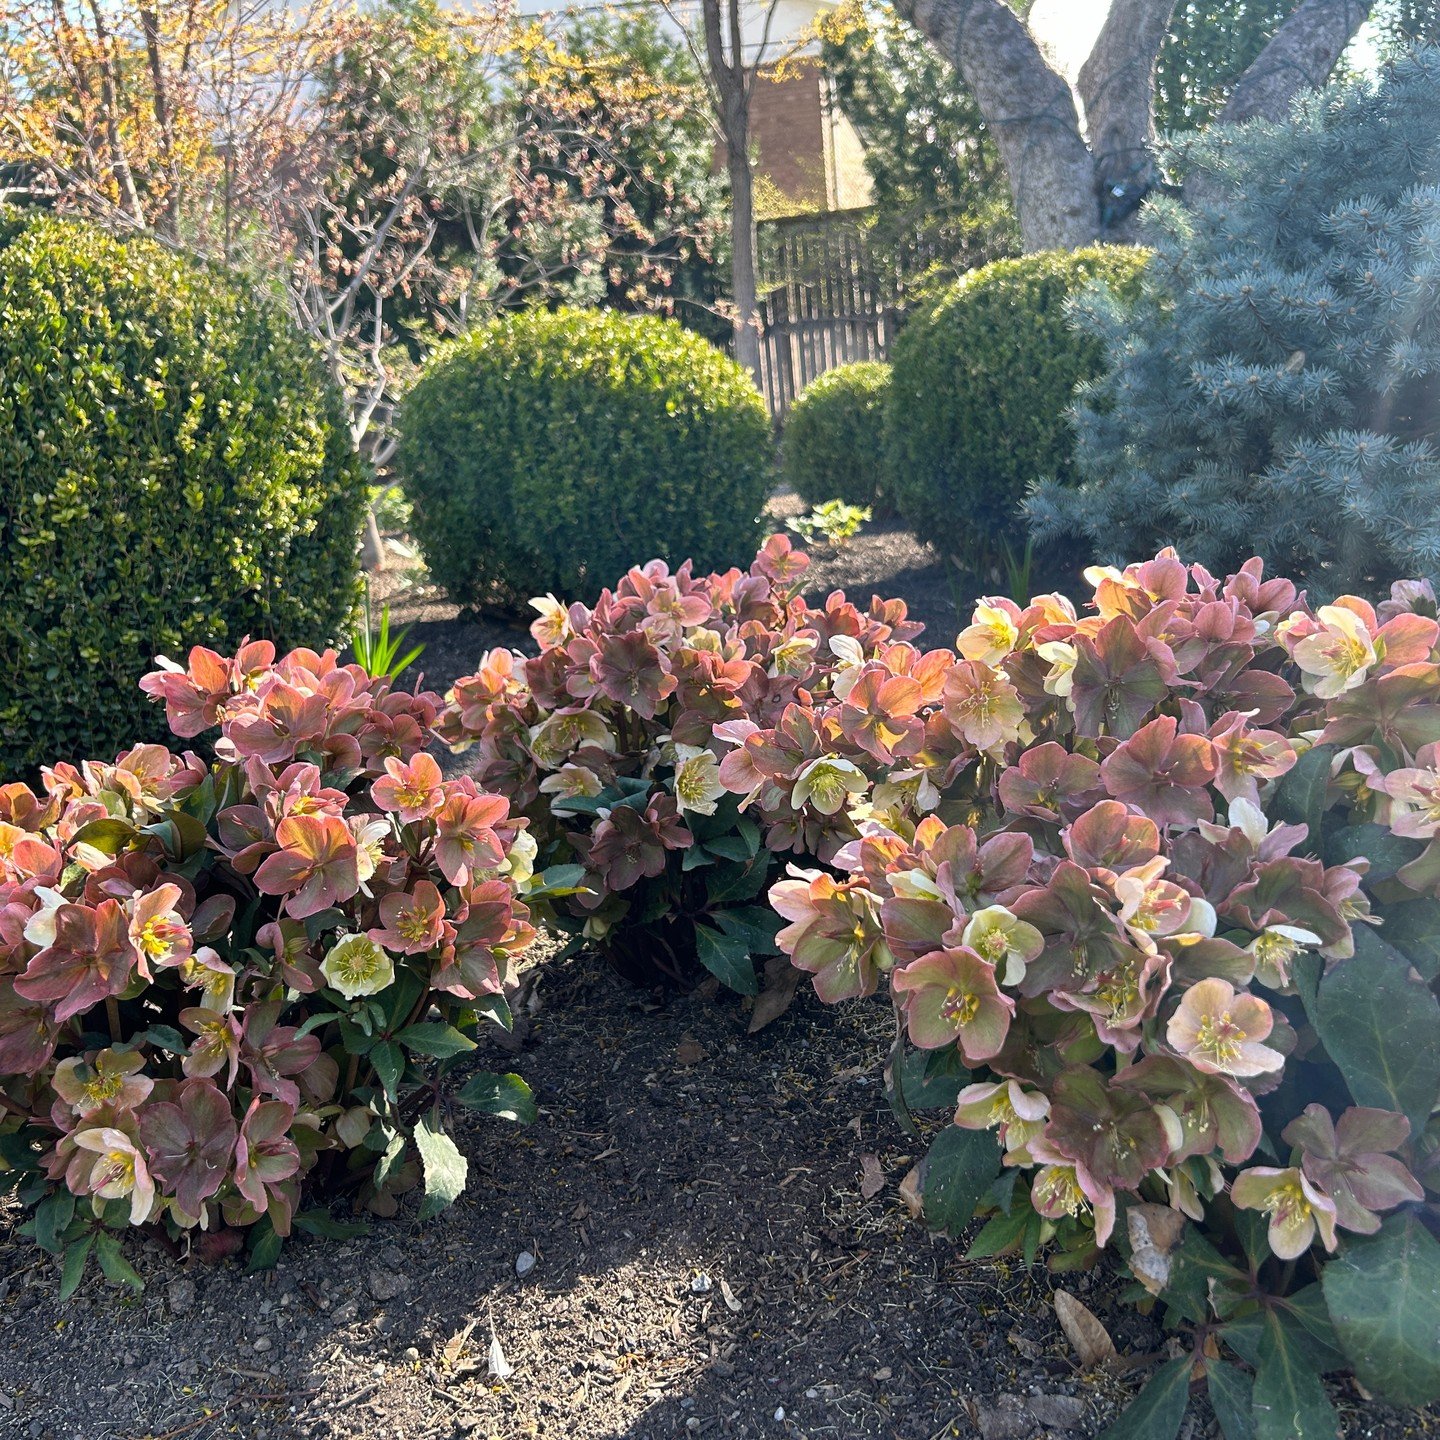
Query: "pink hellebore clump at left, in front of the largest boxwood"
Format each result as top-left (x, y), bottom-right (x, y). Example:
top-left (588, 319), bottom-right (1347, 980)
top-left (0, 642), bottom-right (534, 1292)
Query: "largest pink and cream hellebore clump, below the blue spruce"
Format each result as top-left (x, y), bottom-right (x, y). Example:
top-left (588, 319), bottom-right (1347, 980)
top-left (748, 552), bottom-right (1440, 1440)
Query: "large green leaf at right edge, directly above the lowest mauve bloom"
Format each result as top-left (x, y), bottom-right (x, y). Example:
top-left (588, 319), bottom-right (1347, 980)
top-left (1310, 924), bottom-right (1440, 1135)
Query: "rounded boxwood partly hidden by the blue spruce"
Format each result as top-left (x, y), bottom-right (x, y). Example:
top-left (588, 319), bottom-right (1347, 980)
top-left (887, 245), bottom-right (1148, 583)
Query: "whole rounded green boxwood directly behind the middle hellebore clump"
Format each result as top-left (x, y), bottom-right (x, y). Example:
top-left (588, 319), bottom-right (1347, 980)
top-left (397, 310), bottom-right (773, 606)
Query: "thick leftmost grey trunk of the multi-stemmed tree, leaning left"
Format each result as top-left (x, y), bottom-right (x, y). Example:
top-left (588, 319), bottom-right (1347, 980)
top-left (896, 0), bottom-right (1100, 251)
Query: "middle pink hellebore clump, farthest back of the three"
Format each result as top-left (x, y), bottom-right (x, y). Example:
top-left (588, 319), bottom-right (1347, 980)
top-left (438, 536), bottom-right (920, 1021)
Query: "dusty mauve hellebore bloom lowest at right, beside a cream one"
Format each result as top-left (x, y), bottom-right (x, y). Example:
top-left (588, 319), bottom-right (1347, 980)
top-left (1282, 1104), bottom-right (1424, 1236)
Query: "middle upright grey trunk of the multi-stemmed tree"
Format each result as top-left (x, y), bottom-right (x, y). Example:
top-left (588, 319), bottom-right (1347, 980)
top-left (1076, 0), bottom-right (1175, 218)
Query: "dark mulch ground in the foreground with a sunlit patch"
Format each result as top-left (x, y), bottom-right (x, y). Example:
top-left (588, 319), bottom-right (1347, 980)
top-left (0, 958), bottom-right (1434, 1440)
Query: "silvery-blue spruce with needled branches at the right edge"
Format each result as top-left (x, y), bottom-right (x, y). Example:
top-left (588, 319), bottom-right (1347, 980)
top-left (1030, 50), bottom-right (1440, 599)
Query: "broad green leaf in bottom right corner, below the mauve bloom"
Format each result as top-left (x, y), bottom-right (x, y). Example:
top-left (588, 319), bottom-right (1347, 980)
top-left (1322, 1214), bottom-right (1440, 1405)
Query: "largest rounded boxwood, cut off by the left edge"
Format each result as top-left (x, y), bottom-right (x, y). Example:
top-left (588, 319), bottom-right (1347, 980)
top-left (0, 212), bottom-right (366, 778)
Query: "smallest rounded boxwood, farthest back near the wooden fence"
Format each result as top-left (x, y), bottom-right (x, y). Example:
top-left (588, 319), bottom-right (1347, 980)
top-left (780, 360), bottom-right (890, 514)
